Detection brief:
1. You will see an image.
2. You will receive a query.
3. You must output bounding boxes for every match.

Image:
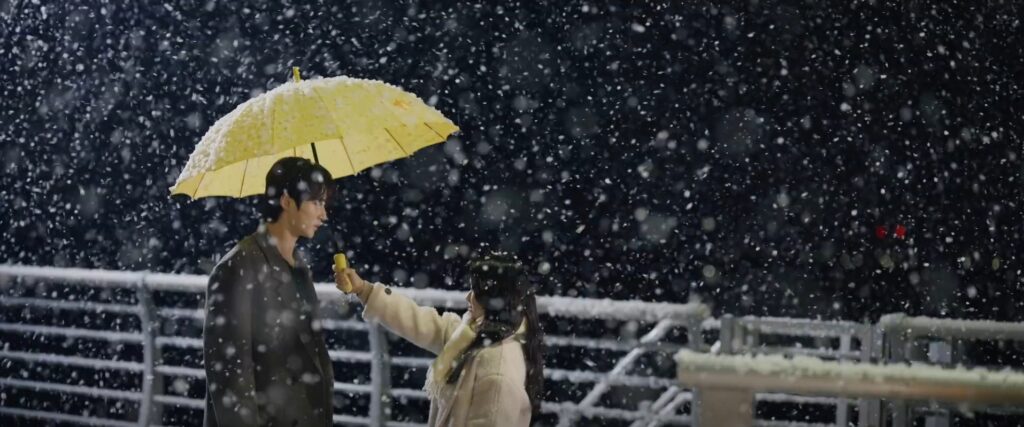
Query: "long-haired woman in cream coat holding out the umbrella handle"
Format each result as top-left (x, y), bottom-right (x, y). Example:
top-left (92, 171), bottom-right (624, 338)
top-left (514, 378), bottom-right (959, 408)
top-left (335, 255), bottom-right (544, 427)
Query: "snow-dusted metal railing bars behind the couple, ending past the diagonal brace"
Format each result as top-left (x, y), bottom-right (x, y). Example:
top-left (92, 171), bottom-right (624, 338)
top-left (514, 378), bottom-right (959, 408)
top-left (0, 265), bottom-right (710, 426)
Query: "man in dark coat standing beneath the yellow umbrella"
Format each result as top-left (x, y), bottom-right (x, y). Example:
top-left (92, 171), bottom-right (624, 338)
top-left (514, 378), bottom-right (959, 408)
top-left (203, 158), bottom-right (334, 427)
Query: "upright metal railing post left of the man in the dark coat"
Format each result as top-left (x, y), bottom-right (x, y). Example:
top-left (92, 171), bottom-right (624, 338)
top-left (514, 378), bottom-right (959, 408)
top-left (135, 273), bottom-right (164, 427)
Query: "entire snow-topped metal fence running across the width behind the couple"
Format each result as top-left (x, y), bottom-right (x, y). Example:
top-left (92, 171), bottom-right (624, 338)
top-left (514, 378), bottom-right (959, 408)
top-left (0, 265), bottom-right (1024, 427)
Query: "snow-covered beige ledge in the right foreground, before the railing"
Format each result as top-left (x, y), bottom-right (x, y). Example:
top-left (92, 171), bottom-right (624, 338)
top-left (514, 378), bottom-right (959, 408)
top-left (676, 350), bottom-right (1024, 426)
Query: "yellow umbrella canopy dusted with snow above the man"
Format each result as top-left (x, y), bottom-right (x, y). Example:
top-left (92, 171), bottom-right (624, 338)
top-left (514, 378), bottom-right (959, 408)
top-left (171, 68), bottom-right (459, 199)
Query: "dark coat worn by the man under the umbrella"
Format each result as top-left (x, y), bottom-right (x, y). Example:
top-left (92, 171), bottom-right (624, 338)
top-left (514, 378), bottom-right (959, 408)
top-left (203, 227), bottom-right (334, 427)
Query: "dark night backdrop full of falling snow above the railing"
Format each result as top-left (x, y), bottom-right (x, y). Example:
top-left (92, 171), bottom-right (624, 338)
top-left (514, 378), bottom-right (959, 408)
top-left (0, 0), bottom-right (1024, 321)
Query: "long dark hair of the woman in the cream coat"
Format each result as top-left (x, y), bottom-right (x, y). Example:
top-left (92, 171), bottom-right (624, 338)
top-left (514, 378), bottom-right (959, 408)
top-left (449, 254), bottom-right (544, 414)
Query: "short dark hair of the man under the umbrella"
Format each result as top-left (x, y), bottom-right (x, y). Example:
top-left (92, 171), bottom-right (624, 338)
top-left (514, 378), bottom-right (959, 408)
top-left (260, 157), bottom-right (334, 222)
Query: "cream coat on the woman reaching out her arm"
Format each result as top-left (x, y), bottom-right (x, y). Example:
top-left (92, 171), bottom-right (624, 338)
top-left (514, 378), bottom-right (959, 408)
top-left (359, 284), bottom-right (530, 427)
